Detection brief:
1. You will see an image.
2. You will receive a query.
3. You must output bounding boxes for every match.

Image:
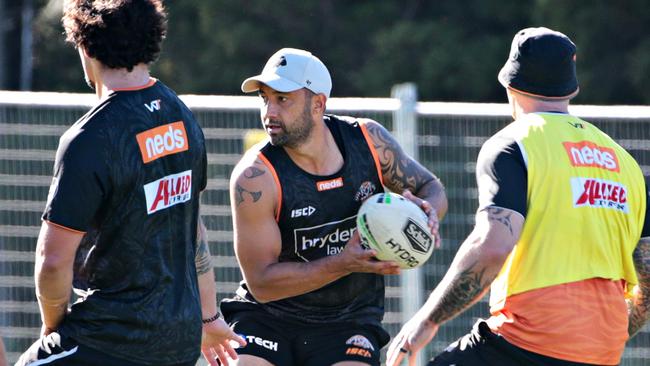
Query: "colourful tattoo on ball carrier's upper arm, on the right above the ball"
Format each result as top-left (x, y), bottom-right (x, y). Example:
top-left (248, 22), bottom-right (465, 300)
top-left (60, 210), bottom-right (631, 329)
top-left (368, 124), bottom-right (434, 193)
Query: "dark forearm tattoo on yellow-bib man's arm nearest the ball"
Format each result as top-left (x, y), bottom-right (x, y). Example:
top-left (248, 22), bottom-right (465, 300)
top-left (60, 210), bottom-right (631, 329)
top-left (429, 261), bottom-right (486, 324)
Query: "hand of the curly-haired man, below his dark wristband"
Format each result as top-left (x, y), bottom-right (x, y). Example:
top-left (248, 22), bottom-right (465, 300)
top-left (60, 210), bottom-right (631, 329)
top-left (201, 319), bottom-right (246, 366)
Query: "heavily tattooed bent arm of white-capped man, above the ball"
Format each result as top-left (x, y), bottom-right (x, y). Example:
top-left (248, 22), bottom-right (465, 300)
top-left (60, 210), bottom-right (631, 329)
top-left (364, 120), bottom-right (447, 219)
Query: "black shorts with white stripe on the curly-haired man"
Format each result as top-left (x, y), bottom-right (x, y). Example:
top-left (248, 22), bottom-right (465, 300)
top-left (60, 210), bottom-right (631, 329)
top-left (14, 332), bottom-right (196, 366)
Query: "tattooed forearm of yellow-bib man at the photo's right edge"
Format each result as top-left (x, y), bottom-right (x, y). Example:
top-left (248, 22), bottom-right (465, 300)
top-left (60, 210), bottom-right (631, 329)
top-left (628, 238), bottom-right (650, 337)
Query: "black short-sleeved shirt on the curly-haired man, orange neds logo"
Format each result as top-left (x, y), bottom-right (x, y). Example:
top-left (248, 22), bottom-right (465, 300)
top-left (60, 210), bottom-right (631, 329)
top-left (43, 81), bottom-right (207, 364)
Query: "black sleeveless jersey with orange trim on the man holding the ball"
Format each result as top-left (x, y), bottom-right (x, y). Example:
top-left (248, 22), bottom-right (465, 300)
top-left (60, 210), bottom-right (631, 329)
top-left (230, 115), bottom-right (384, 323)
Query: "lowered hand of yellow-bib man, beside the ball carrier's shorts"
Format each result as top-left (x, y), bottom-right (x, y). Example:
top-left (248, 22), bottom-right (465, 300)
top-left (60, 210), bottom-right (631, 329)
top-left (386, 313), bottom-right (438, 366)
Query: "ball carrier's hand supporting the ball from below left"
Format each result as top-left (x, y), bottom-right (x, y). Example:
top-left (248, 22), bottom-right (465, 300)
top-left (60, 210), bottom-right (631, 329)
top-left (339, 231), bottom-right (400, 275)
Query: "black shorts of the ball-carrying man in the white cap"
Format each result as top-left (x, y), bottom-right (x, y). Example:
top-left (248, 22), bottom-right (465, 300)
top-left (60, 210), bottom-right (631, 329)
top-left (221, 303), bottom-right (390, 366)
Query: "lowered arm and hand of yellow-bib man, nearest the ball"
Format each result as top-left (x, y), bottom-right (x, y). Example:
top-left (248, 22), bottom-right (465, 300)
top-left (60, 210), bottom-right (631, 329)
top-left (387, 206), bottom-right (524, 365)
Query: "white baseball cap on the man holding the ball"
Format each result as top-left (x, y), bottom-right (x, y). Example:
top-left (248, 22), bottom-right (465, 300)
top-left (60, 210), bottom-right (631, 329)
top-left (241, 48), bottom-right (332, 98)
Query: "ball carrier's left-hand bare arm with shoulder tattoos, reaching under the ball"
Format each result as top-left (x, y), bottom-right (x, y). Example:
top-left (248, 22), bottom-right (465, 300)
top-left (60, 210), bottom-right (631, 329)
top-left (230, 155), bottom-right (399, 302)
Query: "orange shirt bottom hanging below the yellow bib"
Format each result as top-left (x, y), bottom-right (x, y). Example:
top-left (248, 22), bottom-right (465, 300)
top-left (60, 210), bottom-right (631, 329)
top-left (488, 278), bottom-right (628, 365)
